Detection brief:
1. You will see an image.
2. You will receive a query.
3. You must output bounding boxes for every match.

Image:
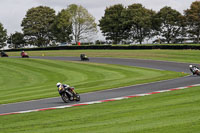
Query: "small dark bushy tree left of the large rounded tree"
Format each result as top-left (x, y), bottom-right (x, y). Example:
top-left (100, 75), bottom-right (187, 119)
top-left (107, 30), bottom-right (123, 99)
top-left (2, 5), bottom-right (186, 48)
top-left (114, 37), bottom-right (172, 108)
top-left (7, 32), bottom-right (25, 49)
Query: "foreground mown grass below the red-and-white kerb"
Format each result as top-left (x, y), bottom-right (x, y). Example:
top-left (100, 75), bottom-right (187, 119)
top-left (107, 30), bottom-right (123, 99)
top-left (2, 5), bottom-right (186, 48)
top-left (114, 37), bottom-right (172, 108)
top-left (0, 87), bottom-right (200, 133)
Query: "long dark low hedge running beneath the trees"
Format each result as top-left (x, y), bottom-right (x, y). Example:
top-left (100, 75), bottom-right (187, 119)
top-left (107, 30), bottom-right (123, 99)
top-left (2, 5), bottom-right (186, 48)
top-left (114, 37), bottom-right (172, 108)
top-left (5, 44), bottom-right (200, 51)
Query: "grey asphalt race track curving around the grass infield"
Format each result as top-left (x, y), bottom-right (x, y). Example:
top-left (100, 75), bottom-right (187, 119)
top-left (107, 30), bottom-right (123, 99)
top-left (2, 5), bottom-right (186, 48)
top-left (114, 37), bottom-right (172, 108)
top-left (0, 56), bottom-right (200, 114)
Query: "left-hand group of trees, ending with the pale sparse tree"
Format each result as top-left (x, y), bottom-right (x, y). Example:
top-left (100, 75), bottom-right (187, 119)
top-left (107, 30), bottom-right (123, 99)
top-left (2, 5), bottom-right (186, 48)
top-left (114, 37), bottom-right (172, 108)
top-left (0, 4), bottom-right (97, 48)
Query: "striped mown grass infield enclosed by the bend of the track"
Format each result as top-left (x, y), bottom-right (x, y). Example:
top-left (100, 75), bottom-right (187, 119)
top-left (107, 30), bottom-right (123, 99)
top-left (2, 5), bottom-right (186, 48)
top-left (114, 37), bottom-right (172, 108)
top-left (0, 58), bottom-right (186, 104)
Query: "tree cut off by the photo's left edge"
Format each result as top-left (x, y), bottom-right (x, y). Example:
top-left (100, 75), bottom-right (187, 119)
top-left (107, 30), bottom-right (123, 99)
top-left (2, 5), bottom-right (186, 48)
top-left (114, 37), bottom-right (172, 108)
top-left (0, 23), bottom-right (7, 48)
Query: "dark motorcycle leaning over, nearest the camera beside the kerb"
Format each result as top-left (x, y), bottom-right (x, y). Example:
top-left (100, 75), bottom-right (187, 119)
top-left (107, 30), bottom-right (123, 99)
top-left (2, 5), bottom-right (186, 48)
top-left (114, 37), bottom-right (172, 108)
top-left (58, 87), bottom-right (80, 103)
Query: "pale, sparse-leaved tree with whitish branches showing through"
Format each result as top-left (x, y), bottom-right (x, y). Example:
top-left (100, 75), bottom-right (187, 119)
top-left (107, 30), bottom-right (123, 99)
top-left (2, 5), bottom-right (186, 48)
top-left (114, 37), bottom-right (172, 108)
top-left (66, 4), bottom-right (97, 43)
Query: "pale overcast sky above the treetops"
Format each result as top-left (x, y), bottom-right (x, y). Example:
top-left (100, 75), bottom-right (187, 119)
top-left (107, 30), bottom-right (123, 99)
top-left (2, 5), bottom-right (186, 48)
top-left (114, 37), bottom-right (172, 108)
top-left (0, 0), bottom-right (195, 40)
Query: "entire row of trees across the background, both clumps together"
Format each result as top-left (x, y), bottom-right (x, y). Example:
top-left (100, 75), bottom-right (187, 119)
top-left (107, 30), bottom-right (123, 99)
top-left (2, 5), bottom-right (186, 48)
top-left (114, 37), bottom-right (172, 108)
top-left (0, 1), bottom-right (200, 48)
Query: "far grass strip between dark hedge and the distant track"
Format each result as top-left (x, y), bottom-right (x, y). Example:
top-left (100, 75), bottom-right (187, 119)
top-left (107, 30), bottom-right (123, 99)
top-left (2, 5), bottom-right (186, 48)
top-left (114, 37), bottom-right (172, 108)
top-left (8, 50), bottom-right (200, 63)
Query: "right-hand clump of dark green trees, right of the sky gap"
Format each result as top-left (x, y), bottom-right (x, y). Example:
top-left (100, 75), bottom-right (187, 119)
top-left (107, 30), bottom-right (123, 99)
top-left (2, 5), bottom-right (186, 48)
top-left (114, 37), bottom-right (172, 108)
top-left (99, 1), bottom-right (200, 44)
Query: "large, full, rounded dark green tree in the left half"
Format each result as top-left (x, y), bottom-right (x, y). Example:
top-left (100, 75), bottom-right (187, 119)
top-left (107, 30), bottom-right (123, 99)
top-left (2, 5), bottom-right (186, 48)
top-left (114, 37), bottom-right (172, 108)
top-left (21, 6), bottom-right (55, 47)
